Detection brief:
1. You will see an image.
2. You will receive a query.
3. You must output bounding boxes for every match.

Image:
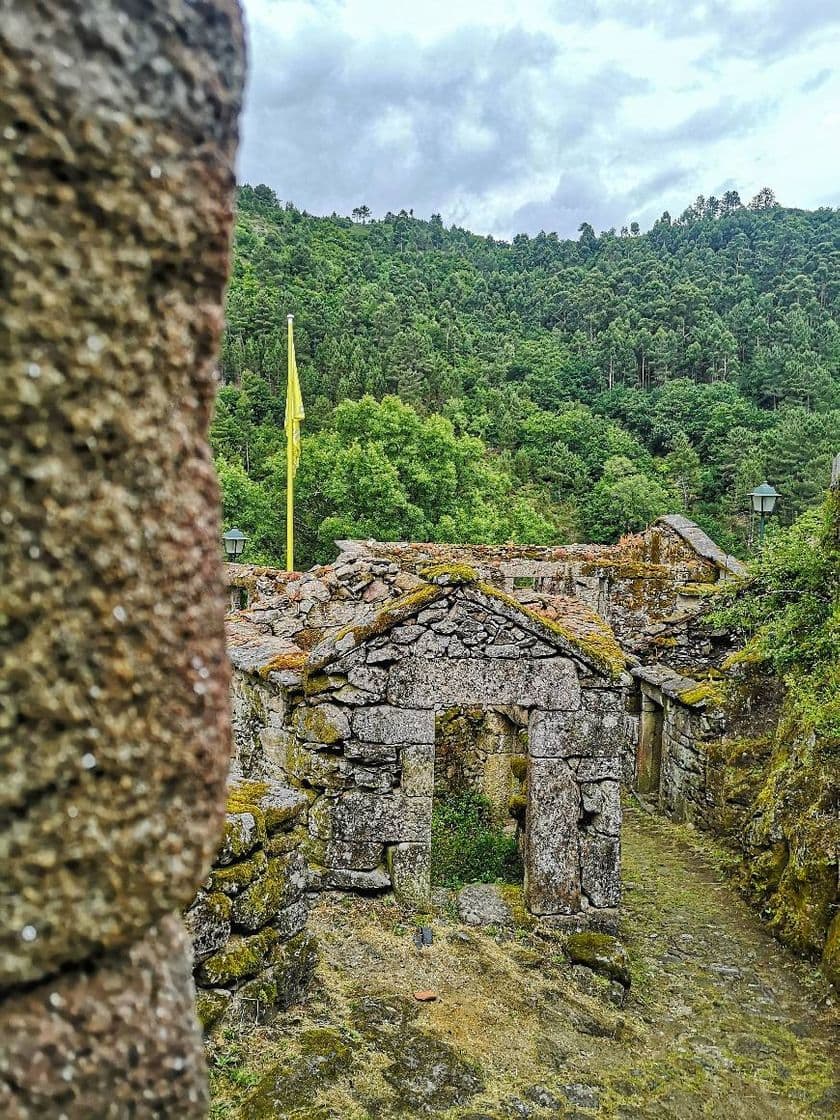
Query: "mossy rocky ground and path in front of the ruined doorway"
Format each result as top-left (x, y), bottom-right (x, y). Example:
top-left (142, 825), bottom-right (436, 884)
top-left (211, 809), bottom-right (840, 1120)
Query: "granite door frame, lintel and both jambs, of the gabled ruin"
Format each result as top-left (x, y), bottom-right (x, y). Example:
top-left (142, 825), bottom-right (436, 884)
top-left (378, 656), bottom-right (620, 916)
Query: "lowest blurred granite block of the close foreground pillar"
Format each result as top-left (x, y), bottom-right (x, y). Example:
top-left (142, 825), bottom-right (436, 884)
top-left (0, 915), bottom-right (208, 1120)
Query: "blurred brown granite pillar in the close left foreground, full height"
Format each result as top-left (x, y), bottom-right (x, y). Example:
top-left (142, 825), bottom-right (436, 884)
top-left (0, 0), bottom-right (243, 1120)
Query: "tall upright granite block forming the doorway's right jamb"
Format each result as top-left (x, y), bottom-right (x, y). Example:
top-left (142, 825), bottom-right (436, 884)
top-left (525, 757), bottom-right (580, 915)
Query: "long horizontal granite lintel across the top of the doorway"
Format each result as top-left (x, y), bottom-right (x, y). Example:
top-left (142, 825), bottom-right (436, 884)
top-left (388, 657), bottom-right (580, 711)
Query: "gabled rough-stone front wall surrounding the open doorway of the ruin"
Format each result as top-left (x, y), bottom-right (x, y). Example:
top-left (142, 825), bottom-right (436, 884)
top-left (224, 560), bottom-right (629, 921)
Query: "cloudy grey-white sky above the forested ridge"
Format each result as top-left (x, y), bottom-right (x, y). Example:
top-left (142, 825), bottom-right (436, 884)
top-left (240, 0), bottom-right (840, 237)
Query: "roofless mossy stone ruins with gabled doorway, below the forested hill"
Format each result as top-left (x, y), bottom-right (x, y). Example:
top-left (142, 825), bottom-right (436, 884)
top-left (187, 516), bottom-right (743, 1027)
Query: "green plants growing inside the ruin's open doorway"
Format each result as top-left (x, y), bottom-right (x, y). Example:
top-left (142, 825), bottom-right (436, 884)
top-left (431, 790), bottom-right (522, 887)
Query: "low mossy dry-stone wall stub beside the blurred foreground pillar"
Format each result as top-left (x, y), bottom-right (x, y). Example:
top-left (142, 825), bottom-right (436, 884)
top-left (185, 780), bottom-right (317, 1032)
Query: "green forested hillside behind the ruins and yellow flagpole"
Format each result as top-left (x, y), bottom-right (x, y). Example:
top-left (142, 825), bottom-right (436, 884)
top-left (213, 186), bottom-right (840, 566)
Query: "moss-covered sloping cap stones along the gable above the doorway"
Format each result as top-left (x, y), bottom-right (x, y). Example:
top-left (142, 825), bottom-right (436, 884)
top-left (305, 563), bottom-right (626, 680)
